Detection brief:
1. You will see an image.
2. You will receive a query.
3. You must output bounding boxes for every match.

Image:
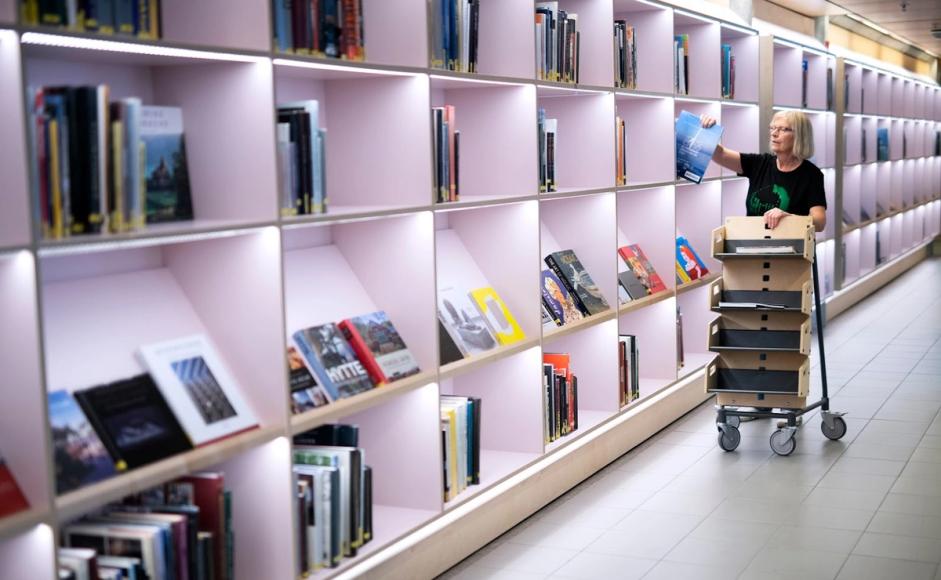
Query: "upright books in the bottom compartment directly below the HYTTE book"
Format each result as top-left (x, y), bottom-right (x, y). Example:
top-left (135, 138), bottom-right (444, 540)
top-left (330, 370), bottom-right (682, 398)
top-left (293, 424), bottom-right (373, 575)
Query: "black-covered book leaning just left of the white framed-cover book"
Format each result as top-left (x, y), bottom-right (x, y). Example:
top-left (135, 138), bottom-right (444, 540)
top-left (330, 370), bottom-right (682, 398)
top-left (75, 374), bottom-right (193, 468)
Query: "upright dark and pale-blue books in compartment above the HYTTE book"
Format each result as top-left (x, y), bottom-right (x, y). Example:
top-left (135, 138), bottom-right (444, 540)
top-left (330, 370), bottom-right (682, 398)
top-left (277, 99), bottom-right (327, 217)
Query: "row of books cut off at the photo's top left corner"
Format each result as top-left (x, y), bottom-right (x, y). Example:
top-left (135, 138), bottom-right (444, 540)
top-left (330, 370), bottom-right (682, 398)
top-left (19, 0), bottom-right (163, 40)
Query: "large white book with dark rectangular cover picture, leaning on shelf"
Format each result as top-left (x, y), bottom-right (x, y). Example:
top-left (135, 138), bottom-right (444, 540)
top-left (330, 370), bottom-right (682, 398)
top-left (138, 334), bottom-right (258, 447)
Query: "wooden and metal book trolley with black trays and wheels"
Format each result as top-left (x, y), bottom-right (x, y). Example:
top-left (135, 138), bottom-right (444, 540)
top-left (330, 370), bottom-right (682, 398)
top-left (706, 216), bottom-right (846, 455)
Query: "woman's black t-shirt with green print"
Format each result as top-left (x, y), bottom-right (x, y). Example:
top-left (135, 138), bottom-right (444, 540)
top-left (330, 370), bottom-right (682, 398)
top-left (740, 153), bottom-right (827, 216)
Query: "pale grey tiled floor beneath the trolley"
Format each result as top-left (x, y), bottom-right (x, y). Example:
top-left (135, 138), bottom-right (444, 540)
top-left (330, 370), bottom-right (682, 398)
top-left (444, 258), bottom-right (941, 580)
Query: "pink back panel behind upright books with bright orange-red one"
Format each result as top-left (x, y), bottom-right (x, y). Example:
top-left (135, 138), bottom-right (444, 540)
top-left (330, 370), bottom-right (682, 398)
top-left (543, 320), bottom-right (620, 414)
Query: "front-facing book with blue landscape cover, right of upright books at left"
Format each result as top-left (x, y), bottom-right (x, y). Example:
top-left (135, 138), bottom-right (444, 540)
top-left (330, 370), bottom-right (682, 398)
top-left (140, 106), bottom-right (193, 223)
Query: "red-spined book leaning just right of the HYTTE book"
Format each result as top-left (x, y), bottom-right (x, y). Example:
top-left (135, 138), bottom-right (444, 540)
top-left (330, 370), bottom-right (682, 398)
top-left (337, 310), bottom-right (420, 385)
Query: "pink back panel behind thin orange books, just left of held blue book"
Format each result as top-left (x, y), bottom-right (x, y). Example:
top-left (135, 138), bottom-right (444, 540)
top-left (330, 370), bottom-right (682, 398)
top-left (617, 95), bottom-right (676, 185)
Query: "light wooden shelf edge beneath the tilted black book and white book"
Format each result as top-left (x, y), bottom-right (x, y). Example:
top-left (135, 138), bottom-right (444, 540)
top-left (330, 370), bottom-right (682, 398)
top-left (56, 427), bottom-right (284, 522)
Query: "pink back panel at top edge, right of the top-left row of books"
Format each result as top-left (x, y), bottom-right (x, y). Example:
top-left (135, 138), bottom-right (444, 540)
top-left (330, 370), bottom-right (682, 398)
top-left (160, 0), bottom-right (272, 50)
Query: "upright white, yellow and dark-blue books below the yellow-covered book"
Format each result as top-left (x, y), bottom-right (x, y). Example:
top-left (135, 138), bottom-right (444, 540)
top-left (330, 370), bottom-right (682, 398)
top-left (439, 395), bottom-right (481, 502)
